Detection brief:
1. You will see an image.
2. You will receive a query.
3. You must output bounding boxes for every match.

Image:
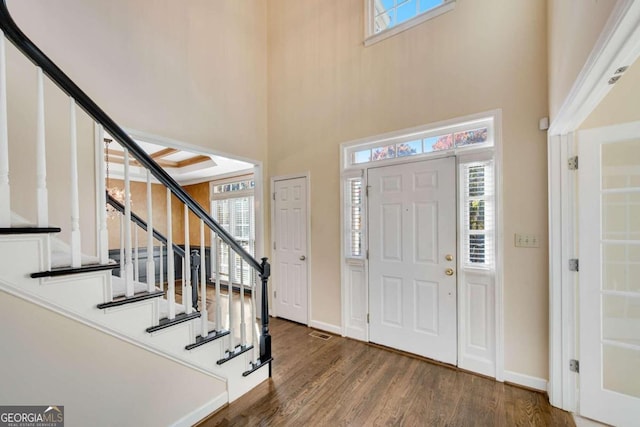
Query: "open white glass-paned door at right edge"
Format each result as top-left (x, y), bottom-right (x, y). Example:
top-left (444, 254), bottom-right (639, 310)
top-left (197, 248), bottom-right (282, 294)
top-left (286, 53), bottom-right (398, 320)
top-left (578, 122), bottom-right (640, 426)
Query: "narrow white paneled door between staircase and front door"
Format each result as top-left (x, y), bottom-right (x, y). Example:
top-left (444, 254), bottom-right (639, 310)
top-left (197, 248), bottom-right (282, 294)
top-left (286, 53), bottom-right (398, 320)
top-left (273, 178), bottom-right (308, 325)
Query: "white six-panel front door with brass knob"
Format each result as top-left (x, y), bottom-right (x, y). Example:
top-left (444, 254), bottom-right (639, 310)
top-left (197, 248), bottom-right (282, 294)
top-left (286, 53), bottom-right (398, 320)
top-left (367, 157), bottom-right (457, 364)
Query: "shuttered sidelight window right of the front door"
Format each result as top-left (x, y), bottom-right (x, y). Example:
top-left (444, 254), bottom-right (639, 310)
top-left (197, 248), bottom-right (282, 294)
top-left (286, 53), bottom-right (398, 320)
top-left (461, 161), bottom-right (495, 269)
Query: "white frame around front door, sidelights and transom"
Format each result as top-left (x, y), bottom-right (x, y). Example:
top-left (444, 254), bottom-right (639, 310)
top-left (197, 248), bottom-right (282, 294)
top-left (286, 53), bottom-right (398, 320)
top-left (339, 109), bottom-right (504, 382)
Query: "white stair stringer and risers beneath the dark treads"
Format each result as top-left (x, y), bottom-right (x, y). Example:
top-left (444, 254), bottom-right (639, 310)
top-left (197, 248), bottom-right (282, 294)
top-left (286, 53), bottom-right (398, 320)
top-left (0, 234), bottom-right (268, 401)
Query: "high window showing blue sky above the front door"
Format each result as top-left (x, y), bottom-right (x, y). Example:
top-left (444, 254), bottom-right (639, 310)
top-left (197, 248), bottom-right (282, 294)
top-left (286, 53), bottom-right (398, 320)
top-left (365, 0), bottom-right (455, 45)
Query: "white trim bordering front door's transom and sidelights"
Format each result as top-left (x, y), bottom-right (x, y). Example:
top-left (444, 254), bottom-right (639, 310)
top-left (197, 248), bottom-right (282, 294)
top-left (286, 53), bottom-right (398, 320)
top-left (340, 109), bottom-right (504, 385)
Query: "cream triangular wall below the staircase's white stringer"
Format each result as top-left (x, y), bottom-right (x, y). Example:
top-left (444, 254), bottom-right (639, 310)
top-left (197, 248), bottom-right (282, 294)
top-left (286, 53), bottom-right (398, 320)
top-left (0, 291), bottom-right (226, 426)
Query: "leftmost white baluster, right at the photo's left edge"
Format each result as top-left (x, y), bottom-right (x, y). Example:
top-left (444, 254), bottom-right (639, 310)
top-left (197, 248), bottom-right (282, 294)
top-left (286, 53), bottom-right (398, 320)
top-left (0, 31), bottom-right (11, 228)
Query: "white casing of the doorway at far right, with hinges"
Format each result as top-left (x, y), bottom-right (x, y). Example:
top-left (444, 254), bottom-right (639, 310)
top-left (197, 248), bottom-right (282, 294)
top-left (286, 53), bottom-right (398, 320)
top-left (547, 0), bottom-right (640, 412)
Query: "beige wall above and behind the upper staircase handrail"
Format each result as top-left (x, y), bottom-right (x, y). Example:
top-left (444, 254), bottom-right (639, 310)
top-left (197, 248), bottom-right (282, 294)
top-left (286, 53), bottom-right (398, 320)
top-left (7, 0), bottom-right (267, 253)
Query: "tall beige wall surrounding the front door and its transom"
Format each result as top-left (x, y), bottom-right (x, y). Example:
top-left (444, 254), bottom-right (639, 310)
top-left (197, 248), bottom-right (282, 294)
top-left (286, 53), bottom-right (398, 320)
top-left (268, 0), bottom-right (548, 378)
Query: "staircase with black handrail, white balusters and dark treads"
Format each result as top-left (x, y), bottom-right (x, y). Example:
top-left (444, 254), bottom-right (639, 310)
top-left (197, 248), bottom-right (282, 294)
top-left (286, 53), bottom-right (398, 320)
top-left (0, 0), bottom-right (272, 425)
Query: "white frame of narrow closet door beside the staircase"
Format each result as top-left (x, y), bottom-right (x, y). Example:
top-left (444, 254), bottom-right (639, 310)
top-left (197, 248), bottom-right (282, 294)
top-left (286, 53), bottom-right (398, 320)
top-left (269, 171), bottom-right (312, 330)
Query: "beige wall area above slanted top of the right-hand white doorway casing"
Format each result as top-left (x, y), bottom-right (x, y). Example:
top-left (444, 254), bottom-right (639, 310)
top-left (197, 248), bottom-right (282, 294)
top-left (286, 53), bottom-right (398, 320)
top-left (548, 0), bottom-right (617, 121)
